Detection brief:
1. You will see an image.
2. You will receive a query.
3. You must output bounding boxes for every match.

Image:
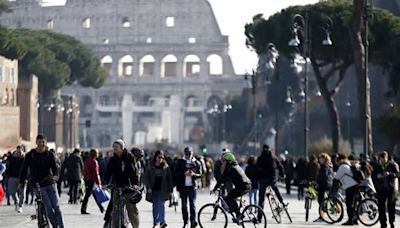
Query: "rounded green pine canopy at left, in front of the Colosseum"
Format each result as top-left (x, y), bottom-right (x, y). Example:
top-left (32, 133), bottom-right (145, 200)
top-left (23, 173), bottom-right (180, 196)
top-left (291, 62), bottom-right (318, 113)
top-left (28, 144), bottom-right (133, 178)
top-left (12, 29), bottom-right (106, 95)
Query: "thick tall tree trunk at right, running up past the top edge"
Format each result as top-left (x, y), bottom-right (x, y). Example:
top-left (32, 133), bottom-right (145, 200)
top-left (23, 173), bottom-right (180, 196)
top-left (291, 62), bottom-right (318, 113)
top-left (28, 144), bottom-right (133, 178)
top-left (349, 0), bottom-right (373, 155)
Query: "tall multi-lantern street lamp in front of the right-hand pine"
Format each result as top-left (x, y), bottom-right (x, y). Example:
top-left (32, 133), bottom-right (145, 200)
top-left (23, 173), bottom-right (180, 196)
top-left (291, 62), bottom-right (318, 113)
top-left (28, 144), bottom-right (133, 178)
top-left (289, 11), bottom-right (333, 158)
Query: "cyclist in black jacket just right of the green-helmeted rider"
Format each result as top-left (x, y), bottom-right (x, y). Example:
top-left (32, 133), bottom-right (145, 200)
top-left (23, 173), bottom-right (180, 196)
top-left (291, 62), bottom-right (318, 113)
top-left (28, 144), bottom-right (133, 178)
top-left (257, 144), bottom-right (287, 209)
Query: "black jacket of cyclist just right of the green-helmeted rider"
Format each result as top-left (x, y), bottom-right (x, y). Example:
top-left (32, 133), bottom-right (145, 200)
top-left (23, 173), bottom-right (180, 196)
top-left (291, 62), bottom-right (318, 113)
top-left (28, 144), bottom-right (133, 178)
top-left (257, 152), bottom-right (285, 180)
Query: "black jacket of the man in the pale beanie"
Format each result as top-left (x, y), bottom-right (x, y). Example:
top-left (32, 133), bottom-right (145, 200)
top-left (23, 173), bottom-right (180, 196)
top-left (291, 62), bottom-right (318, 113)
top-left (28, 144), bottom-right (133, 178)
top-left (107, 151), bottom-right (139, 187)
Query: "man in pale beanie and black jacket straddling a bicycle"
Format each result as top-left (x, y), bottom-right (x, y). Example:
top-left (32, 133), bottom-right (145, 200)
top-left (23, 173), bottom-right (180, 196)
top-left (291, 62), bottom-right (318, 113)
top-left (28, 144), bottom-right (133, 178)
top-left (107, 139), bottom-right (139, 228)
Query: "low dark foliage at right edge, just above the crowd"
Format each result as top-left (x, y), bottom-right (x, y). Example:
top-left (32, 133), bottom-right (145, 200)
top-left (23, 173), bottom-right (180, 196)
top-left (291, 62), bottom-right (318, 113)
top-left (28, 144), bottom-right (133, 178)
top-left (377, 105), bottom-right (400, 153)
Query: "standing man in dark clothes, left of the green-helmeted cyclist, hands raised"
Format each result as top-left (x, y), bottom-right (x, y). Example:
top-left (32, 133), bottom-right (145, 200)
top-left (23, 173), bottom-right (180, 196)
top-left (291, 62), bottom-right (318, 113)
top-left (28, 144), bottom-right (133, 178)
top-left (174, 147), bottom-right (201, 228)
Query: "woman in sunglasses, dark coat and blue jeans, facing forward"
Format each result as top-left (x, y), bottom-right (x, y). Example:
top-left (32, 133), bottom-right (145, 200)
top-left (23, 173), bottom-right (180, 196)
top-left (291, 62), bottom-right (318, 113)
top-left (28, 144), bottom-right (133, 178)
top-left (144, 150), bottom-right (173, 228)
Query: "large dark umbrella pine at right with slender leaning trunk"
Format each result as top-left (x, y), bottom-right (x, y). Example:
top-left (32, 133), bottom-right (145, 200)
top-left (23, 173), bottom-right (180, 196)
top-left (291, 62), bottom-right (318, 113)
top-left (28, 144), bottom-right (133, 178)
top-left (245, 0), bottom-right (400, 155)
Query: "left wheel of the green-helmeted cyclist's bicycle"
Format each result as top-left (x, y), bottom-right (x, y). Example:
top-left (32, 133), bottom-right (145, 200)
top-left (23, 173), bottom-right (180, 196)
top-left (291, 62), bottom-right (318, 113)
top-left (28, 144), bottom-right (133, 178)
top-left (197, 203), bottom-right (228, 228)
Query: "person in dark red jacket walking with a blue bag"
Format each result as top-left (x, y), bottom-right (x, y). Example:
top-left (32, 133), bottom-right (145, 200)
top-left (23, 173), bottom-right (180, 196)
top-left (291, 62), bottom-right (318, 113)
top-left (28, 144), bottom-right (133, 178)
top-left (81, 149), bottom-right (104, 215)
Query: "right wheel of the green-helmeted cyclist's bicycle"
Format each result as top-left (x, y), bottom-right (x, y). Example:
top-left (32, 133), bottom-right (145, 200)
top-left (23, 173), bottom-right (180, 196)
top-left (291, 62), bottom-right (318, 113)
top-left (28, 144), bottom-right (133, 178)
top-left (242, 204), bottom-right (267, 228)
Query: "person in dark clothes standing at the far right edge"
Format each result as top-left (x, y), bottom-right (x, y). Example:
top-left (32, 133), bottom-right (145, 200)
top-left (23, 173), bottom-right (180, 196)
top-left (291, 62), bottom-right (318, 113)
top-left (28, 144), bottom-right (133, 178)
top-left (372, 151), bottom-right (399, 228)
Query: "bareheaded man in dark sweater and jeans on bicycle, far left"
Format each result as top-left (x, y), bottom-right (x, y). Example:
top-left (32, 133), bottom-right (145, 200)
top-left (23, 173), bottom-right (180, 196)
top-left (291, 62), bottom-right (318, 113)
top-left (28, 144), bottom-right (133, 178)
top-left (19, 135), bottom-right (64, 228)
